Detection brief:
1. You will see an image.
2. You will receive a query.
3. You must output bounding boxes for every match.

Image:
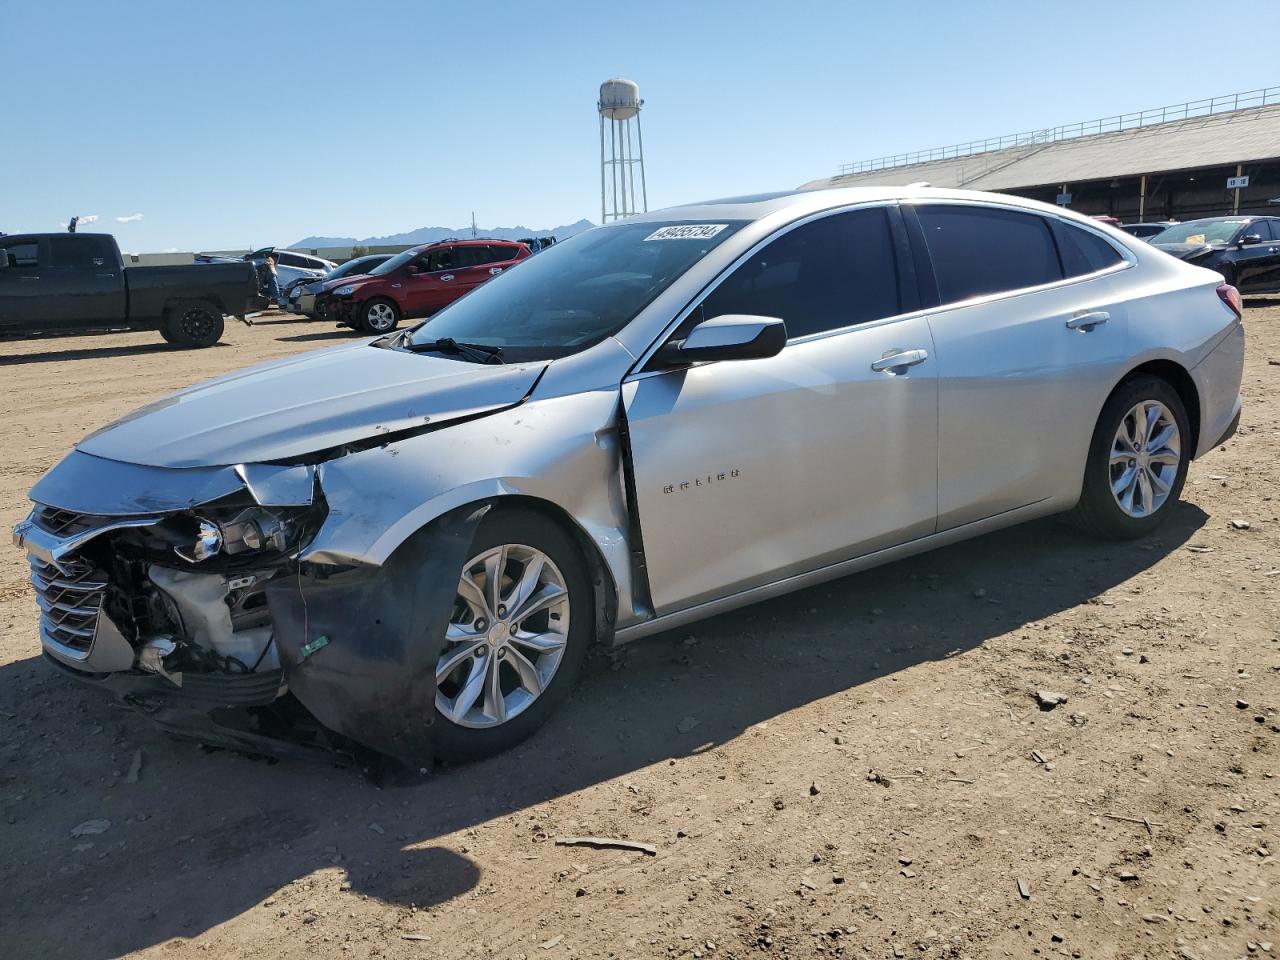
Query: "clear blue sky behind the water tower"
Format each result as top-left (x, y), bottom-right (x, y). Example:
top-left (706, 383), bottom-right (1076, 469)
top-left (0, 0), bottom-right (1280, 251)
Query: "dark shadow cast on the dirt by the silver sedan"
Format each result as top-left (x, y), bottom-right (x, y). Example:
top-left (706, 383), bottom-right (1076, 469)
top-left (0, 503), bottom-right (1207, 960)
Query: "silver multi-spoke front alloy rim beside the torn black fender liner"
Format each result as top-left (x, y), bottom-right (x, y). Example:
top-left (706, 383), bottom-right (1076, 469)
top-left (435, 544), bottom-right (570, 728)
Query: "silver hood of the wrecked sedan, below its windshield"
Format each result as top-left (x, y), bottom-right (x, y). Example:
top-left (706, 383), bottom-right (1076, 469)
top-left (78, 342), bottom-right (547, 467)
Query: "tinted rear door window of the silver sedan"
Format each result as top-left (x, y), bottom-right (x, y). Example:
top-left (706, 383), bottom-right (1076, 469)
top-left (915, 205), bottom-right (1062, 303)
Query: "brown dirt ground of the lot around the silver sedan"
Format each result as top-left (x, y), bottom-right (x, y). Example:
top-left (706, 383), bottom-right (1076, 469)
top-left (0, 308), bottom-right (1280, 960)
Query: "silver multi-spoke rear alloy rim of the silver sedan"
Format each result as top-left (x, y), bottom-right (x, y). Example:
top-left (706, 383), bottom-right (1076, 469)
top-left (1110, 399), bottom-right (1183, 518)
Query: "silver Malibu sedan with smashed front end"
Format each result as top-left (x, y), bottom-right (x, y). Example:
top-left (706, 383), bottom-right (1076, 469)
top-left (15, 187), bottom-right (1244, 767)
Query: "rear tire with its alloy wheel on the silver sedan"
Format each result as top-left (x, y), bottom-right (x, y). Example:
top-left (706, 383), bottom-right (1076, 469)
top-left (1070, 375), bottom-right (1194, 540)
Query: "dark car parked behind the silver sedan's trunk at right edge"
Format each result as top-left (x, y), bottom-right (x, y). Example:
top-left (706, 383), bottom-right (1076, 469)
top-left (1151, 216), bottom-right (1280, 293)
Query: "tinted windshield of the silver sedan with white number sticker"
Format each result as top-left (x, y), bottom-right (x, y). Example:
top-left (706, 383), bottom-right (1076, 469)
top-left (408, 220), bottom-right (745, 361)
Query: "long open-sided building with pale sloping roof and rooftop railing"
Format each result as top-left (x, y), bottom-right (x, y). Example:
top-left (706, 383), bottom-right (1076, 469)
top-left (804, 87), bottom-right (1280, 221)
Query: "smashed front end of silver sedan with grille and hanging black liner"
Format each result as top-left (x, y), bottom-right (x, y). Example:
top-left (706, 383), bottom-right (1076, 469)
top-left (14, 451), bottom-right (483, 769)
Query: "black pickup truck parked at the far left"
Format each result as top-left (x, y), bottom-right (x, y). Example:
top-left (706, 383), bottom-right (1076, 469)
top-left (0, 233), bottom-right (266, 347)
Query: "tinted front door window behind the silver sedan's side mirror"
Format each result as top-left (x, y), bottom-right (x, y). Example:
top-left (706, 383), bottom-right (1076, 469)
top-left (703, 209), bottom-right (901, 339)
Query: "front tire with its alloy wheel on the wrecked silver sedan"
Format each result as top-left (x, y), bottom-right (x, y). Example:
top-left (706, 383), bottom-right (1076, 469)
top-left (435, 509), bottom-right (595, 763)
